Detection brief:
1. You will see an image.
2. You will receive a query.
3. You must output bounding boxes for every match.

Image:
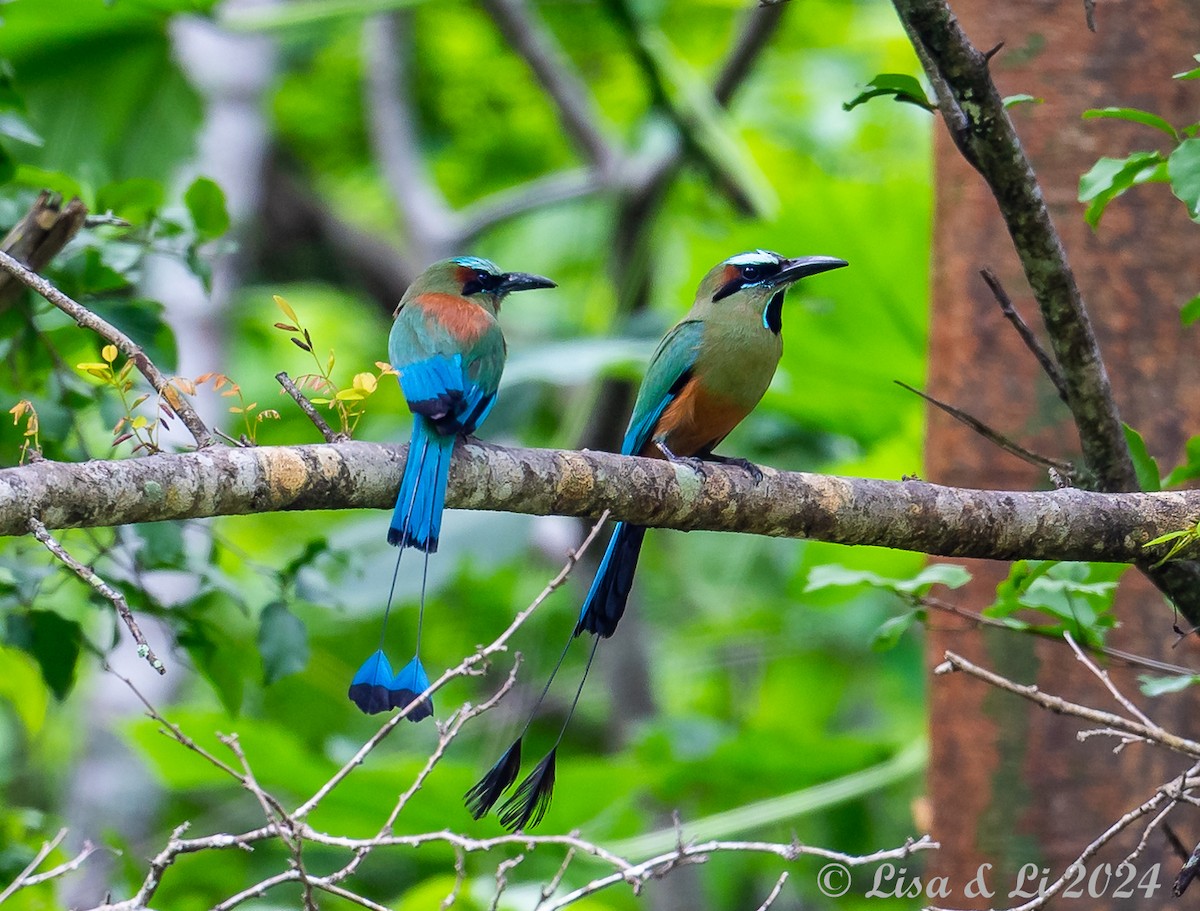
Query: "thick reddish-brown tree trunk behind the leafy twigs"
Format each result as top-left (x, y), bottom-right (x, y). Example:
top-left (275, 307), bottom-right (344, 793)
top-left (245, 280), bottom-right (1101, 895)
top-left (926, 0), bottom-right (1200, 907)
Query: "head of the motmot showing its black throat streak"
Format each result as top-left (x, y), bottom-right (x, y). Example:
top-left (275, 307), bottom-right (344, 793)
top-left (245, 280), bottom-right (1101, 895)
top-left (696, 250), bottom-right (850, 335)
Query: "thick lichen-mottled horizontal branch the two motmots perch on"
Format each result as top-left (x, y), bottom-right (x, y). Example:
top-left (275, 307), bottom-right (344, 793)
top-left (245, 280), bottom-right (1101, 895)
top-left (7, 442), bottom-right (1200, 571)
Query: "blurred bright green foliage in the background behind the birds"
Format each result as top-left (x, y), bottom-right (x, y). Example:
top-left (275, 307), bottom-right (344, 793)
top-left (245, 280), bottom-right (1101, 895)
top-left (0, 0), bottom-right (940, 911)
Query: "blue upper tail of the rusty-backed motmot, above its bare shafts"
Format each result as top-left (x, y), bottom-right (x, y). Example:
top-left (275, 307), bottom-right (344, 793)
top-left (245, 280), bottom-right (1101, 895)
top-left (388, 416), bottom-right (455, 553)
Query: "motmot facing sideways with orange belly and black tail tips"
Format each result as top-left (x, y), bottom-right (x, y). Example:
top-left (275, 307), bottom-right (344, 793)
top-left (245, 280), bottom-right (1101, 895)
top-left (466, 250), bottom-right (847, 831)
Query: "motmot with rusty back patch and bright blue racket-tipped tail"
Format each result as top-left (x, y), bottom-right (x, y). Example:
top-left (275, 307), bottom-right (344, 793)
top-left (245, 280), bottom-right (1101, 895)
top-left (349, 256), bottom-right (554, 721)
